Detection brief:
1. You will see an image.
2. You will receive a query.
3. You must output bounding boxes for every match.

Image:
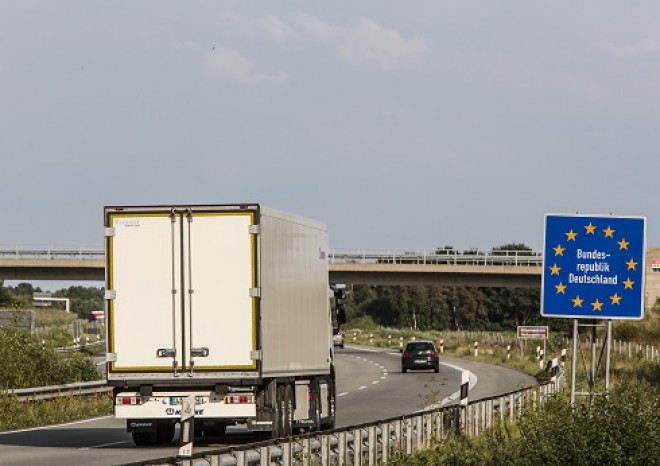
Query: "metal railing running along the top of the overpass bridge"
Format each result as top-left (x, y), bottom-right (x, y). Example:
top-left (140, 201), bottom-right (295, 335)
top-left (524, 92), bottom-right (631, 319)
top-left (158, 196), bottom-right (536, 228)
top-left (0, 244), bottom-right (543, 267)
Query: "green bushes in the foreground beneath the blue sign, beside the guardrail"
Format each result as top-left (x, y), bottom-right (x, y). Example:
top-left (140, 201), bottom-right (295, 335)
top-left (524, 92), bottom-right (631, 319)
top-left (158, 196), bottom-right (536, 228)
top-left (392, 379), bottom-right (660, 466)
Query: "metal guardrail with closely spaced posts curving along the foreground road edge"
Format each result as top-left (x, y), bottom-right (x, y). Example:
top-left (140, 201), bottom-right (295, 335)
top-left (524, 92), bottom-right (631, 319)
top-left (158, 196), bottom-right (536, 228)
top-left (118, 373), bottom-right (564, 466)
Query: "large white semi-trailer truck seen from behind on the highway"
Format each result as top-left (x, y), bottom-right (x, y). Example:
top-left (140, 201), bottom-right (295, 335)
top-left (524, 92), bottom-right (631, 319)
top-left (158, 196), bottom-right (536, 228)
top-left (104, 204), bottom-right (335, 445)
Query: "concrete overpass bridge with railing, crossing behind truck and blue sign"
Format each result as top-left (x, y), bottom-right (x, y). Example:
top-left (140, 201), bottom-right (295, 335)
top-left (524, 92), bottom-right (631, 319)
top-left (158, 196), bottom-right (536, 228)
top-left (0, 246), bottom-right (660, 307)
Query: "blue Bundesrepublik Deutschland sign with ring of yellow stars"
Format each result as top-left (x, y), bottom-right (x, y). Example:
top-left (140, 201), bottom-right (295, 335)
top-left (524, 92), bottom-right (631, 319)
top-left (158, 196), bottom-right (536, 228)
top-left (541, 214), bottom-right (646, 320)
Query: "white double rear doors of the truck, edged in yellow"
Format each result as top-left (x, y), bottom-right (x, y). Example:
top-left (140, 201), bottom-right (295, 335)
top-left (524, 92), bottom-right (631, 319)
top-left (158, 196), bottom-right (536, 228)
top-left (106, 207), bottom-right (258, 379)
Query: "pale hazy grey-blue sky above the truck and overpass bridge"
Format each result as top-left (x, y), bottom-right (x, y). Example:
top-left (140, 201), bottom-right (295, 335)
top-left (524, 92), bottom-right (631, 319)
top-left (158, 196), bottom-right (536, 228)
top-left (0, 0), bottom-right (660, 256)
